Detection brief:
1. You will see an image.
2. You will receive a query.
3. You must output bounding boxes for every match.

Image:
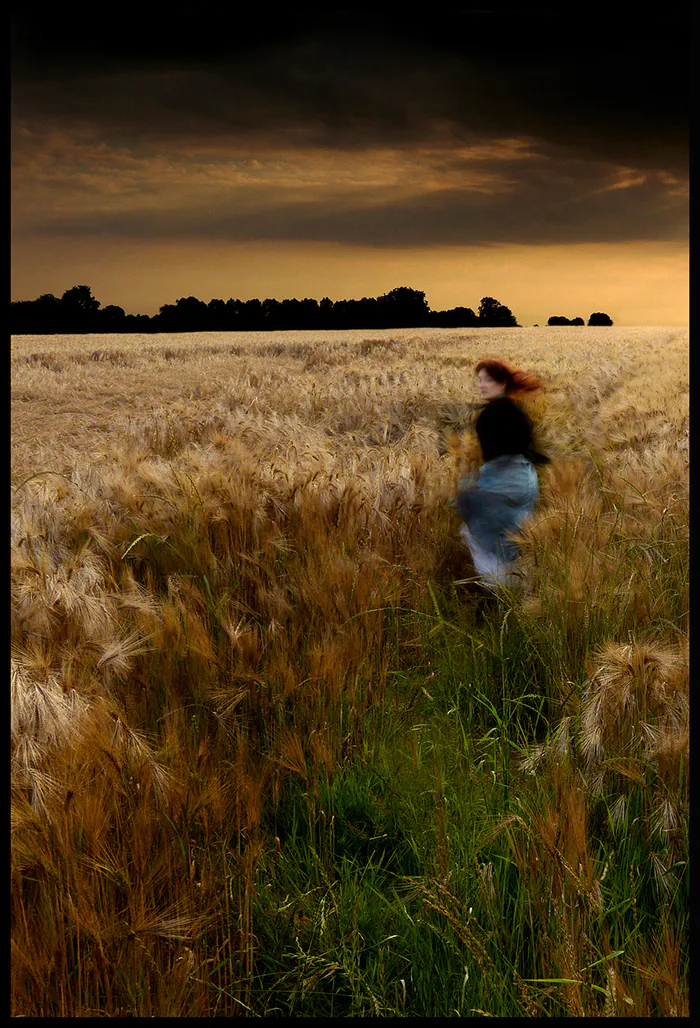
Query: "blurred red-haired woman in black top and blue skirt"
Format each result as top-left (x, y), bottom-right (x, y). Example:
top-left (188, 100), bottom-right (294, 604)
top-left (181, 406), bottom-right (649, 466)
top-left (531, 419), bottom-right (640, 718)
top-left (455, 358), bottom-right (549, 585)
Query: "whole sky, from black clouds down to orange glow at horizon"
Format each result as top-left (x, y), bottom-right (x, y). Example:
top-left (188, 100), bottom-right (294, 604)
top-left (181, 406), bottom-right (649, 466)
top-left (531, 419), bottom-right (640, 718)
top-left (11, 0), bottom-right (690, 325)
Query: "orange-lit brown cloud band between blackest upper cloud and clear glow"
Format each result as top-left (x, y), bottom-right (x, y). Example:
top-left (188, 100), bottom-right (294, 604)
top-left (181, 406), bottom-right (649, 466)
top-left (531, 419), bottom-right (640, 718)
top-left (15, 130), bottom-right (688, 247)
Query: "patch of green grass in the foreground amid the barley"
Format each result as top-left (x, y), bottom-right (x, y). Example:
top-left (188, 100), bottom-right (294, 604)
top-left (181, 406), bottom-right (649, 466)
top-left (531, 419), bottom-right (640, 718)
top-left (242, 571), bottom-right (688, 1017)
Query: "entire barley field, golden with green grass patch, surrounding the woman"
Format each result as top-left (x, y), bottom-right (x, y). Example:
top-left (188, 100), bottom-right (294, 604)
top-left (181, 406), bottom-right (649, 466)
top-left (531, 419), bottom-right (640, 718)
top-left (10, 327), bottom-right (689, 1017)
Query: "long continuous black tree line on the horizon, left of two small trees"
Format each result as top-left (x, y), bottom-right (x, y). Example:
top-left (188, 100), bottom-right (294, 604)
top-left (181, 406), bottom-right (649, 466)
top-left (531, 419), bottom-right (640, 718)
top-left (10, 286), bottom-right (519, 335)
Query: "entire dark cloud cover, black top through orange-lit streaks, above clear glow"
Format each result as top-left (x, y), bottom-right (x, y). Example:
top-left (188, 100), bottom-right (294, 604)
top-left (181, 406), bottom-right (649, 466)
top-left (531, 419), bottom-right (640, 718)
top-left (11, 2), bottom-right (690, 320)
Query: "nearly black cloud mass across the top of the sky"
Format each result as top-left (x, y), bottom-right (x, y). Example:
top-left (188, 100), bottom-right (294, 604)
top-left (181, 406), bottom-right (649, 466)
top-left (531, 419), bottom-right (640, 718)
top-left (12, 4), bottom-right (688, 173)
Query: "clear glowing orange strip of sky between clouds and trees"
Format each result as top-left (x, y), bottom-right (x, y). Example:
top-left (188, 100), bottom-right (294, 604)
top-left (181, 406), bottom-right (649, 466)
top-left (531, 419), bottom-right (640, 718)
top-left (12, 240), bottom-right (689, 326)
